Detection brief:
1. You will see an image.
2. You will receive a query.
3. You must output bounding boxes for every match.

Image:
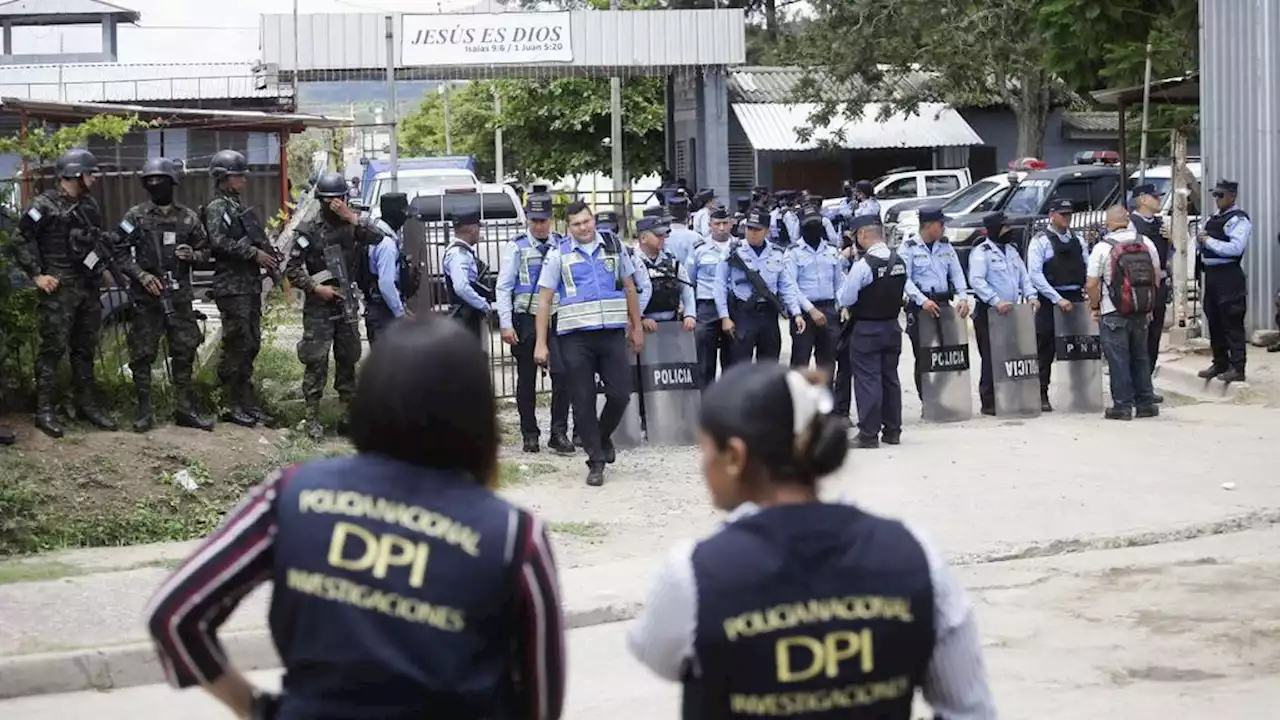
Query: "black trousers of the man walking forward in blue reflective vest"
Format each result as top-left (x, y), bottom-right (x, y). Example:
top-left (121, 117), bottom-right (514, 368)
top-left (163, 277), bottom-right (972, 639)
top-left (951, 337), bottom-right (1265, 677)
top-left (558, 329), bottom-right (635, 468)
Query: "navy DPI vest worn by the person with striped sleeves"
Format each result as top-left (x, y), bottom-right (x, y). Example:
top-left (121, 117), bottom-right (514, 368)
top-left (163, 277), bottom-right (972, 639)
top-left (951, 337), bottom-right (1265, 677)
top-left (269, 455), bottom-right (531, 720)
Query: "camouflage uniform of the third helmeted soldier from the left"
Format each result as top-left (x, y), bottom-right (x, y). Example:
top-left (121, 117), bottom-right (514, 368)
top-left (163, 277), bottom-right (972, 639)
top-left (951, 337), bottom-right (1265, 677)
top-left (204, 190), bottom-right (265, 410)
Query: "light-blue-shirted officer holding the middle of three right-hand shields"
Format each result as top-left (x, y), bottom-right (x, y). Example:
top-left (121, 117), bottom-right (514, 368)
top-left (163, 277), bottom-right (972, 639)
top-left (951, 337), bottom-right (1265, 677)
top-left (969, 213), bottom-right (1039, 415)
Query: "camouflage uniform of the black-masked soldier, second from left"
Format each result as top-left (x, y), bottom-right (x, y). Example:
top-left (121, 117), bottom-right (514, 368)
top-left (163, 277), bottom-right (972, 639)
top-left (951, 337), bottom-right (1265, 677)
top-left (119, 200), bottom-right (211, 410)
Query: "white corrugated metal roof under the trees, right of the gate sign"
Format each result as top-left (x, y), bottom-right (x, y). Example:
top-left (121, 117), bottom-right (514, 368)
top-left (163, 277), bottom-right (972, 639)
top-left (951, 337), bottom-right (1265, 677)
top-left (733, 102), bottom-right (982, 150)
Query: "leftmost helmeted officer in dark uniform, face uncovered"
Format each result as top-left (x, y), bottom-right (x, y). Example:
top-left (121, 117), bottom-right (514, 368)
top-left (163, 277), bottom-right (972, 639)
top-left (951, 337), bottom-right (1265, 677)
top-left (13, 149), bottom-right (116, 438)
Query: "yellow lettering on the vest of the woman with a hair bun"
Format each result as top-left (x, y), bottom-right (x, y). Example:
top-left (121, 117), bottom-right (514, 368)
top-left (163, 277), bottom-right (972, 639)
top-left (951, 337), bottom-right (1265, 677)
top-left (724, 596), bottom-right (914, 716)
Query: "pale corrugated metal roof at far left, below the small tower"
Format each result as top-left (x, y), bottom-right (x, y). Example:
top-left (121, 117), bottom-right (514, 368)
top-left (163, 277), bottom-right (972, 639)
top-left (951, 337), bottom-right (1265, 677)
top-left (0, 63), bottom-right (293, 102)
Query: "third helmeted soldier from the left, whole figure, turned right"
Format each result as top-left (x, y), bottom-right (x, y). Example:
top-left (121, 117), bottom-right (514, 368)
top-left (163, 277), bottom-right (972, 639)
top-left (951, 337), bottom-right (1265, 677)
top-left (204, 150), bottom-right (279, 428)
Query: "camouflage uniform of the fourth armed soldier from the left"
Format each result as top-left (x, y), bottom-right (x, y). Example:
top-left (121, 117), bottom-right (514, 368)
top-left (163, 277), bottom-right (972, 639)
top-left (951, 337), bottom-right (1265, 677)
top-left (284, 214), bottom-right (381, 430)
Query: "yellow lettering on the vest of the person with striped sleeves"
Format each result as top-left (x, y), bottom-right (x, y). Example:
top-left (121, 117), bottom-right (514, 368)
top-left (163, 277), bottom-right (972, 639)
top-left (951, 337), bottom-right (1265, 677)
top-left (285, 489), bottom-right (480, 632)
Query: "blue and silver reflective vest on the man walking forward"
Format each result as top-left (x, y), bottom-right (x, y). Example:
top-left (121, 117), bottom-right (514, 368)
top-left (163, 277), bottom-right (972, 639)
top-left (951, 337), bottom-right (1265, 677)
top-left (556, 234), bottom-right (627, 334)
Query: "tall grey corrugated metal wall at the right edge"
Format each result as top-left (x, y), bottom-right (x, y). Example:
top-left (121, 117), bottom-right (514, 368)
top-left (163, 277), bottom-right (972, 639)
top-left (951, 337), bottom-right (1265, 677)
top-left (1201, 0), bottom-right (1280, 331)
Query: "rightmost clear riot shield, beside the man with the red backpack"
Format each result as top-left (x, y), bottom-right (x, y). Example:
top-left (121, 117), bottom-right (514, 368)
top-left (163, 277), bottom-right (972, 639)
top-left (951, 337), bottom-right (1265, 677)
top-left (1050, 302), bottom-right (1106, 413)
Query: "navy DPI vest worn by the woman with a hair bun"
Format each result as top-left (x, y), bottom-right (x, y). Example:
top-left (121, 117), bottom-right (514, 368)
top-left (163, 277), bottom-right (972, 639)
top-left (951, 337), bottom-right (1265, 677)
top-left (685, 502), bottom-right (936, 720)
